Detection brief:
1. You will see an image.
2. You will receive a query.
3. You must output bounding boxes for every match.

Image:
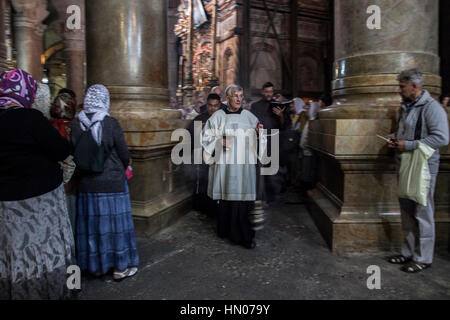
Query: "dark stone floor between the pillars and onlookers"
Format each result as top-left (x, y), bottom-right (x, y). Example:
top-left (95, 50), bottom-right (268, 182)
top-left (79, 192), bottom-right (450, 300)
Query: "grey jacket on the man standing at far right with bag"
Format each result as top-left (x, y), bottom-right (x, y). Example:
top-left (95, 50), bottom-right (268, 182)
top-left (396, 90), bottom-right (449, 174)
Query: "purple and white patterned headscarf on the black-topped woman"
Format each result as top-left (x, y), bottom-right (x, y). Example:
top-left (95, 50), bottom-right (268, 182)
top-left (0, 69), bottom-right (37, 109)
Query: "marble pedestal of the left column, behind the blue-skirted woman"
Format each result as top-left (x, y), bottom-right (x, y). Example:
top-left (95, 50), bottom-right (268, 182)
top-left (112, 108), bottom-right (192, 236)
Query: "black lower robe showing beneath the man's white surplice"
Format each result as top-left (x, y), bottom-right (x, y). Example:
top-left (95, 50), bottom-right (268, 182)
top-left (217, 200), bottom-right (255, 246)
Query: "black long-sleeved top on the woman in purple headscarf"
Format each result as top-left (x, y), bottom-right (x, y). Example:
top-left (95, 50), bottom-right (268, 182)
top-left (0, 108), bottom-right (71, 201)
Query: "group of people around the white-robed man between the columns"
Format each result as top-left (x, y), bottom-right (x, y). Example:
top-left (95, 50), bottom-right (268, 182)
top-left (188, 82), bottom-right (332, 249)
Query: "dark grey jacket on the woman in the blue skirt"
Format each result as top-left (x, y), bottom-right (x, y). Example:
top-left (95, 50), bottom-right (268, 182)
top-left (71, 115), bottom-right (130, 193)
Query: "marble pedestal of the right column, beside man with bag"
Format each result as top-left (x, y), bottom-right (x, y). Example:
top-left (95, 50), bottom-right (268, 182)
top-left (309, 115), bottom-right (450, 252)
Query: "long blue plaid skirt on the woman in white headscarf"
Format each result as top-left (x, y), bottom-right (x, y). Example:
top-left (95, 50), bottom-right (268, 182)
top-left (76, 182), bottom-right (139, 274)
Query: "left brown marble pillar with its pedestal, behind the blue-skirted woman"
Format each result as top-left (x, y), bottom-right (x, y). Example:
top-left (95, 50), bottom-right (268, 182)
top-left (86, 0), bottom-right (191, 234)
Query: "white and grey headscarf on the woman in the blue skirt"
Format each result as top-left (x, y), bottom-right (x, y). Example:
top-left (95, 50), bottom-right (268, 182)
top-left (78, 84), bottom-right (109, 145)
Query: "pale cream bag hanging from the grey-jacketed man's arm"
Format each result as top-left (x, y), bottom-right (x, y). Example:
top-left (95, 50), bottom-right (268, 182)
top-left (398, 141), bottom-right (435, 206)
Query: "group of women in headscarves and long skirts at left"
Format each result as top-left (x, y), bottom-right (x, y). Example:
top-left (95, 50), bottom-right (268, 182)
top-left (0, 69), bottom-right (139, 299)
